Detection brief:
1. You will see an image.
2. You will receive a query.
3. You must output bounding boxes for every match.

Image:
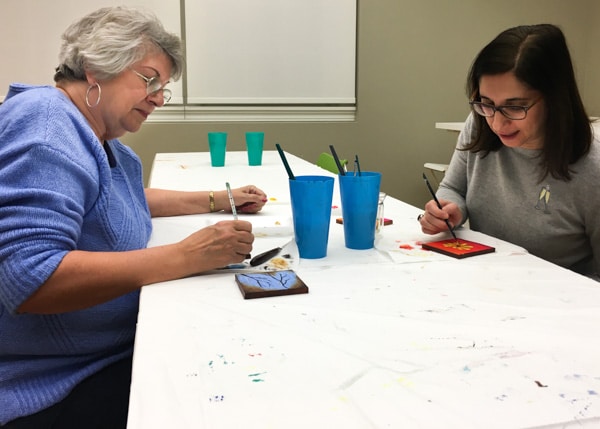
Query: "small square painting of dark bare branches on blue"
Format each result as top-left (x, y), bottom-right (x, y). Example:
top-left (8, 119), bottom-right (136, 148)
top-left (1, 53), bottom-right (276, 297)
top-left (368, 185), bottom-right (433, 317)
top-left (235, 270), bottom-right (308, 299)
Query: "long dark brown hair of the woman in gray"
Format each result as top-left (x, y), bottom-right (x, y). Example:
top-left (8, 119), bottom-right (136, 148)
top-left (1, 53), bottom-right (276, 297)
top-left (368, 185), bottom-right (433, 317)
top-left (465, 24), bottom-right (592, 181)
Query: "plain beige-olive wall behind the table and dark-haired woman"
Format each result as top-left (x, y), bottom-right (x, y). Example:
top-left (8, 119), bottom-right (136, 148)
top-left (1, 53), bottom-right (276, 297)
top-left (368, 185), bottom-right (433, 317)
top-left (123, 0), bottom-right (600, 206)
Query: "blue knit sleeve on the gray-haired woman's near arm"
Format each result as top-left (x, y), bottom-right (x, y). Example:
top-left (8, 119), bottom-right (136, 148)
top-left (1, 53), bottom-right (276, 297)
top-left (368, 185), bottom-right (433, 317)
top-left (0, 93), bottom-right (99, 312)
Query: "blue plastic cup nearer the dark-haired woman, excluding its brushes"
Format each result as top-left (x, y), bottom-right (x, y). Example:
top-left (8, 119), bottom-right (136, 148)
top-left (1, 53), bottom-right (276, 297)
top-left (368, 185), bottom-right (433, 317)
top-left (338, 171), bottom-right (381, 249)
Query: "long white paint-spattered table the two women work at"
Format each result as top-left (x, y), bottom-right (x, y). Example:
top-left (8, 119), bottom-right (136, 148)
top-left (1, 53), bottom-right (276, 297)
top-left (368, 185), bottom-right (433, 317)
top-left (128, 152), bottom-right (600, 429)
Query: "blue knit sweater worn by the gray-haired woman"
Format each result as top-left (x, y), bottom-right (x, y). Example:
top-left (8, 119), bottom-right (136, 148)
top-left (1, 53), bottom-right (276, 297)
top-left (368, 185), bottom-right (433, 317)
top-left (0, 85), bottom-right (152, 424)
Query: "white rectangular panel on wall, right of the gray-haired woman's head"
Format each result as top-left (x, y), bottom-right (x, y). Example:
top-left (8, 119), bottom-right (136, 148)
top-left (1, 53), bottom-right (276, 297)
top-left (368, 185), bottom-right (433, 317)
top-left (185, 0), bottom-right (356, 105)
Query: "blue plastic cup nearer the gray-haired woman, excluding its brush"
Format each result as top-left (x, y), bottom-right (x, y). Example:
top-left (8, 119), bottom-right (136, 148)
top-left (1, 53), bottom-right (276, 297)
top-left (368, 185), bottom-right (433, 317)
top-left (290, 176), bottom-right (334, 259)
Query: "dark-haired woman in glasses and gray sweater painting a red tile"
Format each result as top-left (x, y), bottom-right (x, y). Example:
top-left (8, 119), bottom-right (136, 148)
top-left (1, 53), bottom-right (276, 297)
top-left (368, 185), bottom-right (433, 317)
top-left (419, 24), bottom-right (600, 279)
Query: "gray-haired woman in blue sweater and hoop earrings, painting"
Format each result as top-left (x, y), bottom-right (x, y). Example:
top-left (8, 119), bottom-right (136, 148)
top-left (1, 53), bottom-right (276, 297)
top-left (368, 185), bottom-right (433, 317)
top-left (0, 7), bottom-right (266, 429)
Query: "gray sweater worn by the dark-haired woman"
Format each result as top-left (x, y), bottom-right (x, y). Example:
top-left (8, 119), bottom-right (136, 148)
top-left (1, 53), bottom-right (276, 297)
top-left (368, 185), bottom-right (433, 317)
top-left (437, 116), bottom-right (600, 279)
